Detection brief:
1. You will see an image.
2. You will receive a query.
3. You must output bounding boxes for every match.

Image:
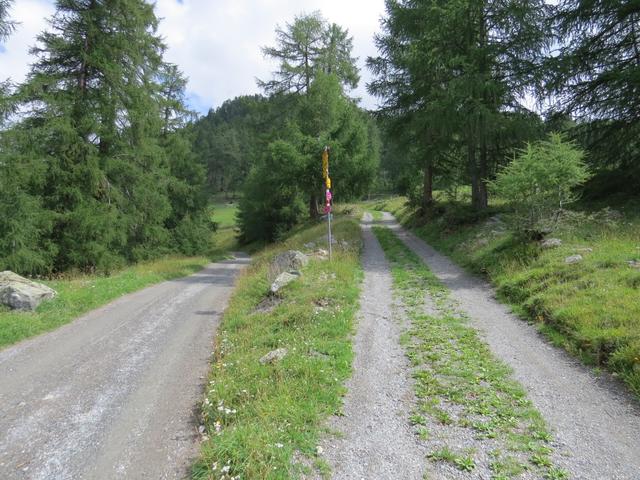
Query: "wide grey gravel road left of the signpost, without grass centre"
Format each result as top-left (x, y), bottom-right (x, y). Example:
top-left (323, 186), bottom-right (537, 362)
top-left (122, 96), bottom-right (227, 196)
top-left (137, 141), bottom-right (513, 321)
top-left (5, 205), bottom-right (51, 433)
top-left (0, 255), bottom-right (249, 480)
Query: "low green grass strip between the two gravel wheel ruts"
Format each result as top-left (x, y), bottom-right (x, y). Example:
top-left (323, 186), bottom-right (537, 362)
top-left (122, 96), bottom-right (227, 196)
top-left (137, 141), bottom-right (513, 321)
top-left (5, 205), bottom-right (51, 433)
top-left (374, 227), bottom-right (567, 479)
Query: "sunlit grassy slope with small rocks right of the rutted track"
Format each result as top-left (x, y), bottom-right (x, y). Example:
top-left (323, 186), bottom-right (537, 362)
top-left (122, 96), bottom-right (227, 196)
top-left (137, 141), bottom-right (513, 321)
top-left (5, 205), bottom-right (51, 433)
top-left (377, 195), bottom-right (640, 395)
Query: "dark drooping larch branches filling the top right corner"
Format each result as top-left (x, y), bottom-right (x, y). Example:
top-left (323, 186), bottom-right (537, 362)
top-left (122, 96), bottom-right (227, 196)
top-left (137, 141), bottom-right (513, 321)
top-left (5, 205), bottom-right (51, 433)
top-left (548, 0), bottom-right (640, 178)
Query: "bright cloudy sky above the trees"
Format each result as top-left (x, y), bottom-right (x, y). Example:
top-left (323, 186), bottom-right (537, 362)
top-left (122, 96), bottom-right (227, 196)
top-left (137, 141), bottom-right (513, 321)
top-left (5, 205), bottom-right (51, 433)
top-left (0, 0), bottom-right (384, 113)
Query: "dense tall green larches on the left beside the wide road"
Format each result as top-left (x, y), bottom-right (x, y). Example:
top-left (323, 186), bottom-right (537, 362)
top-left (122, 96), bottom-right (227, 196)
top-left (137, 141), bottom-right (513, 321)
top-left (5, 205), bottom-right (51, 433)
top-left (0, 0), bottom-right (212, 274)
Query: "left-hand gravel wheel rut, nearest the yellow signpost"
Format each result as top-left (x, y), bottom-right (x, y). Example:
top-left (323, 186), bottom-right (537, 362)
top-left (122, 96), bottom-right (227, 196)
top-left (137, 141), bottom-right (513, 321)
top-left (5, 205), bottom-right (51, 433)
top-left (312, 214), bottom-right (426, 480)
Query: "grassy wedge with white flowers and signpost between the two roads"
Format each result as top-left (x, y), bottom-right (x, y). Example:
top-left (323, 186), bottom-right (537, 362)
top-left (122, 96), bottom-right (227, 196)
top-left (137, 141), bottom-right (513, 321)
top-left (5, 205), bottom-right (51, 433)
top-left (192, 218), bottom-right (362, 479)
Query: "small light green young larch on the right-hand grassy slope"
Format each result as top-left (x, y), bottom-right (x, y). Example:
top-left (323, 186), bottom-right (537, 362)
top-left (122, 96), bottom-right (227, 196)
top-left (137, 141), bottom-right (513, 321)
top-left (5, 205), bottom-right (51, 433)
top-left (490, 134), bottom-right (590, 232)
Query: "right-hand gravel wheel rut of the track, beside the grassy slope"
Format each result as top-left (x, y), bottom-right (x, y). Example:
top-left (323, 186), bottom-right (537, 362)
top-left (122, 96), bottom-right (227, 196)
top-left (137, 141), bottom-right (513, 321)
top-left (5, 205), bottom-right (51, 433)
top-left (384, 213), bottom-right (640, 480)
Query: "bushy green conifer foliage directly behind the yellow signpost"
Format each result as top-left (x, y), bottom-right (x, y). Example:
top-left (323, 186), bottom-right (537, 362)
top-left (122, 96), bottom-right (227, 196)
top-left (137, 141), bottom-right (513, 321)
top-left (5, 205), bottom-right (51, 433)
top-left (239, 69), bottom-right (379, 242)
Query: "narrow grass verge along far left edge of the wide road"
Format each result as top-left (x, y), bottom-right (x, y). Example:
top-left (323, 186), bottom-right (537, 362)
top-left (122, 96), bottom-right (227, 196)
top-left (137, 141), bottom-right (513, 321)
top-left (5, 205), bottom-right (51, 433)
top-left (0, 257), bottom-right (209, 348)
